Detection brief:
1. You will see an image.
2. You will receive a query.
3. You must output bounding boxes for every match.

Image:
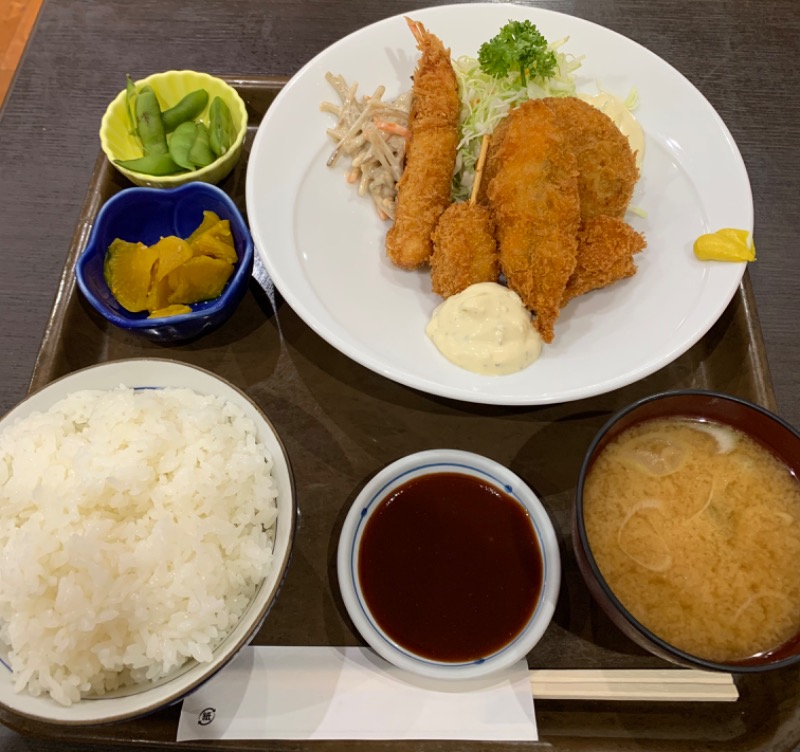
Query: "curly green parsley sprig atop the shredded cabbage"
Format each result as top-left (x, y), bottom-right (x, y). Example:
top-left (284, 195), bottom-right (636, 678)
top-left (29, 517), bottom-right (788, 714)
top-left (478, 21), bottom-right (557, 86)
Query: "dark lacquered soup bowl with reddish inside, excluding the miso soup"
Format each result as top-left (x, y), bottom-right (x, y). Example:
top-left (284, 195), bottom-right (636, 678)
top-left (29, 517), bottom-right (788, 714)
top-left (572, 390), bottom-right (800, 673)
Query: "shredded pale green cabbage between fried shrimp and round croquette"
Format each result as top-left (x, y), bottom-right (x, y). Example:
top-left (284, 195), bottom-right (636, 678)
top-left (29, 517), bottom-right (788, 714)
top-left (452, 37), bottom-right (583, 201)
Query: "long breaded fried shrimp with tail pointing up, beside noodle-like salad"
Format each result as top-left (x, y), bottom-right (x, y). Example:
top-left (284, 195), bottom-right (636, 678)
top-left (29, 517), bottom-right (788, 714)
top-left (386, 19), bottom-right (460, 269)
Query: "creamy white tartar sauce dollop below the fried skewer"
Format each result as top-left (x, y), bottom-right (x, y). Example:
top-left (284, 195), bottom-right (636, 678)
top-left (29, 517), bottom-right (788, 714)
top-left (425, 282), bottom-right (542, 376)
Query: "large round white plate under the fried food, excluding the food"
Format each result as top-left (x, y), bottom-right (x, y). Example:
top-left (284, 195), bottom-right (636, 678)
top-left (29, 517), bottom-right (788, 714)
top-left (247, 4), bottom-right (753, 405)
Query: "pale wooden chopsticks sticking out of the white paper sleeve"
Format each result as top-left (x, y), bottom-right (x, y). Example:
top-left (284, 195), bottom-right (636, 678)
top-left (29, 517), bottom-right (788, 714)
top-left (530, 669), bottom-right (739, 702)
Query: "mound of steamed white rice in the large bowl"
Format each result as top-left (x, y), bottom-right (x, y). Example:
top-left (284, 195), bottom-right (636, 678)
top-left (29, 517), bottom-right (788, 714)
top-left (0, 387), bottom-right (277, 705)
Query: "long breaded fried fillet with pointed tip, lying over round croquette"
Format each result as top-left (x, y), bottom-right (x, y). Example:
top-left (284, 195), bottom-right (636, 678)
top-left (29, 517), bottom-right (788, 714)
top-left (484, 100), bottom-right (580, 342)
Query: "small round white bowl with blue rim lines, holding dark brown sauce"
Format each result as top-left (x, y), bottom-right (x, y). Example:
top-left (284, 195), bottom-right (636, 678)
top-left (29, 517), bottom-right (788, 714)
top-left (337, 449), bottom-right (561, 679)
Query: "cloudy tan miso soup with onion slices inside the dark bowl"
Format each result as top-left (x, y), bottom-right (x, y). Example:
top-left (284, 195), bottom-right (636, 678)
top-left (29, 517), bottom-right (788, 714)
top-left (584, 418), bottom-right (800, 662)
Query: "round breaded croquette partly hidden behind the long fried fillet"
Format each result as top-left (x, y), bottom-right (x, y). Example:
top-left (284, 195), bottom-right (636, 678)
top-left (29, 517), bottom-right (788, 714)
top-left (542, 97), bottom-right (639, 222)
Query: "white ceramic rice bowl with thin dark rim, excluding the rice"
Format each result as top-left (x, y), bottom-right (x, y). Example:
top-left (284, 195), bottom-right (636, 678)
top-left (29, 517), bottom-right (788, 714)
top-left (0, 358), bottom-right (297, 725)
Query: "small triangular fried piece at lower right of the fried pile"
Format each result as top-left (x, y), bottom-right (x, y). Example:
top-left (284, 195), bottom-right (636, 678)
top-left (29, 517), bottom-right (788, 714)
top-left (561, 217), bottom-right (646, 306)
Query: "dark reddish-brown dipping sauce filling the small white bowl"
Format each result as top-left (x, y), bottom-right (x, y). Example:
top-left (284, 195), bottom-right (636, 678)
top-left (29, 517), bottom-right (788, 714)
top-left (358, 473), bottom-right (543, 663)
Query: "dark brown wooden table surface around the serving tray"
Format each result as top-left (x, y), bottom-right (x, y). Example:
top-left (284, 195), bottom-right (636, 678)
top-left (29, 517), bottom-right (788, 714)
top-left (0, 0), bottom-right (800, 750)
